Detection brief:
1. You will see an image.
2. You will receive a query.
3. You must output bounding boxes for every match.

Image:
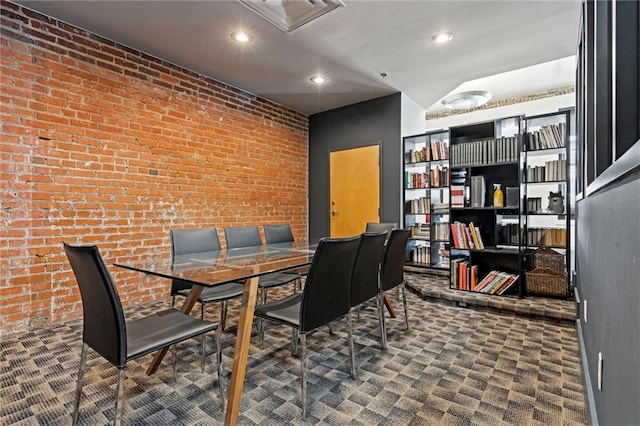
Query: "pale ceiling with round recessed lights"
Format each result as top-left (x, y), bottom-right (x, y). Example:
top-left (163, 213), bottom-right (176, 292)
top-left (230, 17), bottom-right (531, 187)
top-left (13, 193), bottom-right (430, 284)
top-left (16, 0), bottom-right (580, 114)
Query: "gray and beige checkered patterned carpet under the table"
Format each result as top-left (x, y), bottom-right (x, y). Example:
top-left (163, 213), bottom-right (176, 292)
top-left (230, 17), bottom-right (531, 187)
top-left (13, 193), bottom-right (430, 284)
top-left (0, 275), bottom-right (587, 426)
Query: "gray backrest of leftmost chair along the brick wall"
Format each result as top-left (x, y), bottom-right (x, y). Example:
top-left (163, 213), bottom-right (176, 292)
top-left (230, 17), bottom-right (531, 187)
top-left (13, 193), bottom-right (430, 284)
top-left (171, 228), bottom-right (220, 296)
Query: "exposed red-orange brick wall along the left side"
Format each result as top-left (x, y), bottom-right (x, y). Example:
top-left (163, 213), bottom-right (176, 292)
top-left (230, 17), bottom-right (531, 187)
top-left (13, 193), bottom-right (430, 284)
top-left (0, 0), bottom-right (308, 334)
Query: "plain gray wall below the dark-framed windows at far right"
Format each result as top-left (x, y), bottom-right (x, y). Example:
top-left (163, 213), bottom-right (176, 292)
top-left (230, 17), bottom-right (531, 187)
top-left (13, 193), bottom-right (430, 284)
top-left (576, 166), bottom-right (640, 425)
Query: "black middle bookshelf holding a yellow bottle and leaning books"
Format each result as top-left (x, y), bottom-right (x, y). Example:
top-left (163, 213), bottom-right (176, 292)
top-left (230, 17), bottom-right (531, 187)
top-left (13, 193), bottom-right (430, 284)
top-left (449, 117), bottom-right (524, 297)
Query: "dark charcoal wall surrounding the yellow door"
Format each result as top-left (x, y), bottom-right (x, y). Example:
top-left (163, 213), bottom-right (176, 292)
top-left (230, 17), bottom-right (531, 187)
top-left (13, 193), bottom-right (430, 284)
top-left (309, 93), bottom-right (402, 238)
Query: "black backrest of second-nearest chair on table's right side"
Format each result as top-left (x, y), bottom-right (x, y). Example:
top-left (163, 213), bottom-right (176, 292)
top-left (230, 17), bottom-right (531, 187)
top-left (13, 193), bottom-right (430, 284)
top-left (349, 232), bottom-right (387, 307)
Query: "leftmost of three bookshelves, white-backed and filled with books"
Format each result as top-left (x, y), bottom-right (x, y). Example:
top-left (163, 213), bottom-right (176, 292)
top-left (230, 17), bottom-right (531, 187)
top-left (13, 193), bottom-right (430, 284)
top-left (403, 131), bottom-right (450, 271)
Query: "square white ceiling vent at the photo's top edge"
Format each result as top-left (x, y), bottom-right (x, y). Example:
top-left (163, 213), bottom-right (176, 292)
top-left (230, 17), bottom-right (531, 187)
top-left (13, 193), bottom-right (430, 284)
top-left (238, 0), bottom-right (344, 33)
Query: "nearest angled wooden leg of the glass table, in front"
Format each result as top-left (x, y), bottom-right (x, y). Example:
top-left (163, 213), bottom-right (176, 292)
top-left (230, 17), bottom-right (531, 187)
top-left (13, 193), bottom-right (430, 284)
top-left (224, 277), bottom-right (258, 426)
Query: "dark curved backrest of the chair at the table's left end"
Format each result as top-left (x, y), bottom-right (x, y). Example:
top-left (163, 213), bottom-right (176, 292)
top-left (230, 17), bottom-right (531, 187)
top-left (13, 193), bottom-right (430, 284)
top-left (63, 243), bottom-right (127, 367)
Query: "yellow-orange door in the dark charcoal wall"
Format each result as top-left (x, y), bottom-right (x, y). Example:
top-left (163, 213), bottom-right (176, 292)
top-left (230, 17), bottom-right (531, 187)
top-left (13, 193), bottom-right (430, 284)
top-left (329, 145), bottom-right (380, 237)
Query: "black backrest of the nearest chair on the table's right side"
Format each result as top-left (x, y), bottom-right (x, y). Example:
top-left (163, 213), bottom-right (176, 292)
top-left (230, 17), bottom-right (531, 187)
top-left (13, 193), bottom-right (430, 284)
top-left (300, 235), bottom-right (360, 333)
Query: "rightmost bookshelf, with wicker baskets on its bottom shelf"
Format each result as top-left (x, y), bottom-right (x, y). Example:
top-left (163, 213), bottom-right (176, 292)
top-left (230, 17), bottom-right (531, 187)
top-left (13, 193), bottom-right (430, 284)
top-left (522, 111), bottom-right (574, 296)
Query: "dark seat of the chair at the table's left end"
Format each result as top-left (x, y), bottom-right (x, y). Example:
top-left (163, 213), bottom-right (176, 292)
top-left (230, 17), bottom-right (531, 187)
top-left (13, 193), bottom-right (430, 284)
top-left (127, 308), bottom-right (218, 359)
